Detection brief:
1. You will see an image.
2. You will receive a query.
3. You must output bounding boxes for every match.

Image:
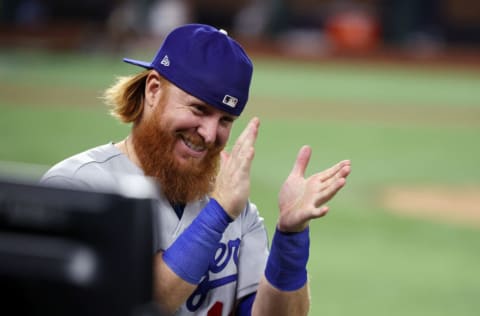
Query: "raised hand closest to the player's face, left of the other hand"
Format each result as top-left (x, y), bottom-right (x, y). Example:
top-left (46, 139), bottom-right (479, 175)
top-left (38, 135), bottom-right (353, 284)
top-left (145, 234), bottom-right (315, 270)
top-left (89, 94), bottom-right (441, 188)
top-left (211, 117), bottom-right (260, 219)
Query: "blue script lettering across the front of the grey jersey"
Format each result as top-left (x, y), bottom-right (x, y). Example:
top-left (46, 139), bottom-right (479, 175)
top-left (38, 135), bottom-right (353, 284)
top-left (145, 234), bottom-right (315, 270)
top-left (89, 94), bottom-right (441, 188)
top-left (186, 238), bottom-right (240, 312)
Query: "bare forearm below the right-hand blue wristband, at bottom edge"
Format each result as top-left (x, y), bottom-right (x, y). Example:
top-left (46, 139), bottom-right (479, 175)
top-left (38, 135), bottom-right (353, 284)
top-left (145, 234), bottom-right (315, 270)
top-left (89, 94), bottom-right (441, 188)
top-left (252, 277), bottom-right (310, 316)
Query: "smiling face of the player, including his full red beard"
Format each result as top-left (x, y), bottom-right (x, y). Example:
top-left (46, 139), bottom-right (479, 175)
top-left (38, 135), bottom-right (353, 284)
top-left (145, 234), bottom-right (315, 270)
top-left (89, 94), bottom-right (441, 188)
top-left (133, 78), bottom-right (235, 203)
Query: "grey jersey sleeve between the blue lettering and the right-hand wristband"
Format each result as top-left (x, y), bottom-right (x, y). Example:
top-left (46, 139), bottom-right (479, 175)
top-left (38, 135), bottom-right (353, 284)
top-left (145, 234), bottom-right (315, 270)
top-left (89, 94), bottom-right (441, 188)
top-left (237, 203), bottom-right (268, 299)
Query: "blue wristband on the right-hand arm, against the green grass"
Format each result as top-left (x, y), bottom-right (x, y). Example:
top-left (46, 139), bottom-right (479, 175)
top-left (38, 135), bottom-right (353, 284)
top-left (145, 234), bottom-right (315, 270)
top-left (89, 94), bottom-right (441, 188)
top-left (265, 227), bottom-right (310, 291)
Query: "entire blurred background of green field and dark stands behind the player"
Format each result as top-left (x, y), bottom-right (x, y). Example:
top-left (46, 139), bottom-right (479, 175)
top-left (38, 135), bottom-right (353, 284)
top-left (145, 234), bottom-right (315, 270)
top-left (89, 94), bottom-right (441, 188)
top-left (0, 0), bottom-right (480, 316)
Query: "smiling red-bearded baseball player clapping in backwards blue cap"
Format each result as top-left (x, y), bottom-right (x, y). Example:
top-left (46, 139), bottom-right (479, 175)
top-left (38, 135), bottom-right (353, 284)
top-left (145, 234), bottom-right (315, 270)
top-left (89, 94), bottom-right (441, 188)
top-left (42, 24), bottom-right (350, 316)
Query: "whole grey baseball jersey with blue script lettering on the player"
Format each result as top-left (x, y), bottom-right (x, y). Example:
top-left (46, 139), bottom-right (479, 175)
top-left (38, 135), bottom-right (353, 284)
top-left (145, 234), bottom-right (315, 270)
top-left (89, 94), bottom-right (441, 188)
top-left (41, 143), bottom-right (268, 316)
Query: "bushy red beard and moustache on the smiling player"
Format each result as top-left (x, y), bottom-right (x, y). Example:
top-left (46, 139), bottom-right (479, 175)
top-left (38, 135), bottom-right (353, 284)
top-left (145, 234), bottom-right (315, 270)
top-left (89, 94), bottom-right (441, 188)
top-left (132, 105), bottom-right (223, 204)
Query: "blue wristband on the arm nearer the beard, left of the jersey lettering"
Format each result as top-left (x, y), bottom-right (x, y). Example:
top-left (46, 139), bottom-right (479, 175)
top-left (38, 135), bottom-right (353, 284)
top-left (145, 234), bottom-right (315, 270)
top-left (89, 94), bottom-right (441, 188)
top-left (163, 198), bottom-right (232, 284)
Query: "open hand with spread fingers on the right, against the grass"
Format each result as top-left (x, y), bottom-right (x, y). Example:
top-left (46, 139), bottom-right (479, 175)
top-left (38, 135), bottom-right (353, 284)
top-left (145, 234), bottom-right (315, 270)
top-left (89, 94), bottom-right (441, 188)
top-left (278, 146), bottom-right (350, 232)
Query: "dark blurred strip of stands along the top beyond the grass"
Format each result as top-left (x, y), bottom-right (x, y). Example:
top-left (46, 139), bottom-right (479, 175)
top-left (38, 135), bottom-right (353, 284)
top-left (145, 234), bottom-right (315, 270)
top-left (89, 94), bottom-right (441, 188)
top-left (0, 0), bottom-right (480, 56)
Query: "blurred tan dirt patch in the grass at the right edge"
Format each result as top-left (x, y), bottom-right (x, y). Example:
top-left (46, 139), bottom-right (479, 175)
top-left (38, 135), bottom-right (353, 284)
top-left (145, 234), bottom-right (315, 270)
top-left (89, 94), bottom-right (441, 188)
top-left (380, 186), bottom-right (480, 228)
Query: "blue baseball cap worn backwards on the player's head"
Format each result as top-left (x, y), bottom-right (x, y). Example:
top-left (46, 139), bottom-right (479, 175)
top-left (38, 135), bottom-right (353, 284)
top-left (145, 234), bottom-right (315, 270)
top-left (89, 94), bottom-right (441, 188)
top-left (123, 24), bottom-right (253, 116)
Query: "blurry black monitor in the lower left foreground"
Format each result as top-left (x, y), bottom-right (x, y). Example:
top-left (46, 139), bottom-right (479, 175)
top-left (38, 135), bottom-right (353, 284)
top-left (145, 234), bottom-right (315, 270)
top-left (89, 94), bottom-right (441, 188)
top-left (0, 179), bottom-right (156, 316)
